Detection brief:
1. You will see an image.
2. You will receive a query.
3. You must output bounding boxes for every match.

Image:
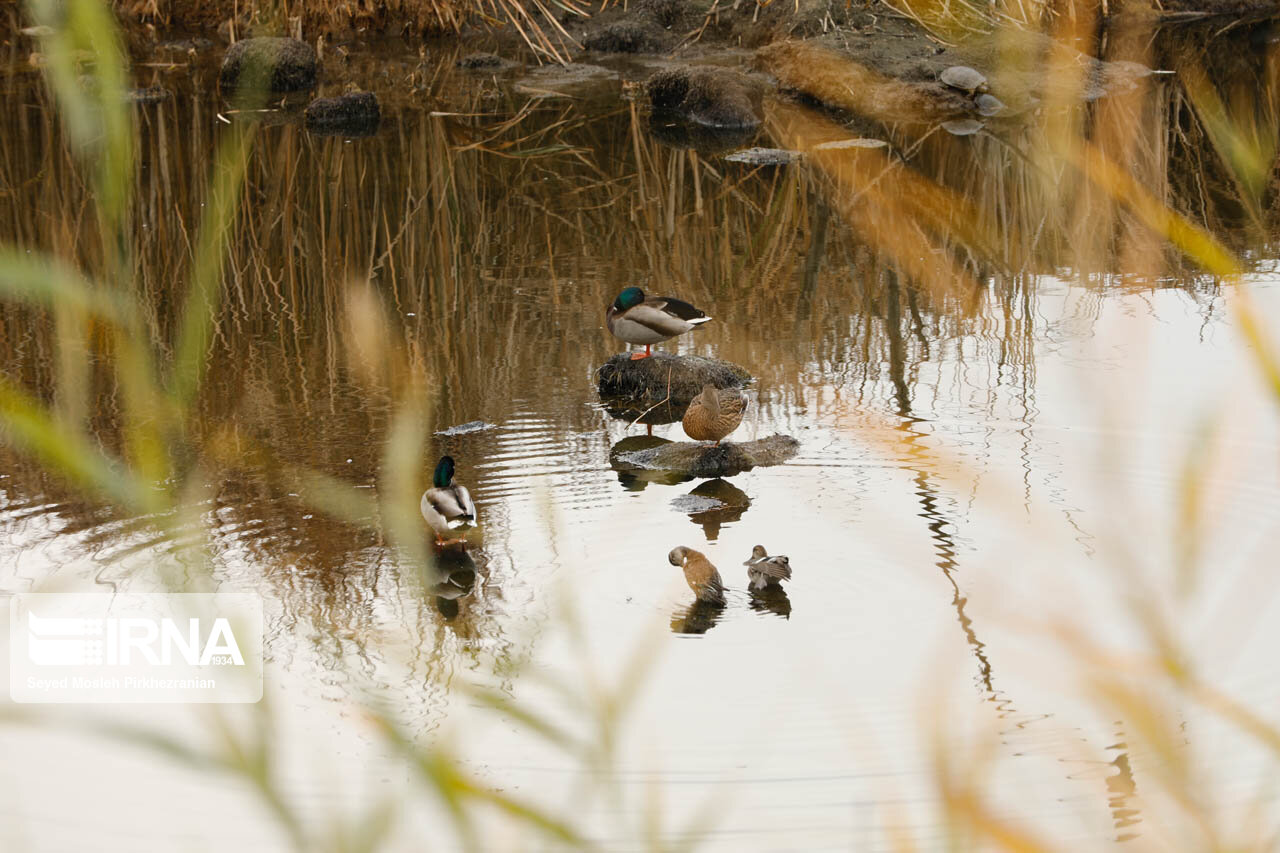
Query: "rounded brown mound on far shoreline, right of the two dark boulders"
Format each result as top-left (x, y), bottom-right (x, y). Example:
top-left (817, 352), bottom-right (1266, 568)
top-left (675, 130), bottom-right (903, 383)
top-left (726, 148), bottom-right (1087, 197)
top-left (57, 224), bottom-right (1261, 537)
top-left (645, 65), bottom-right (760, 129)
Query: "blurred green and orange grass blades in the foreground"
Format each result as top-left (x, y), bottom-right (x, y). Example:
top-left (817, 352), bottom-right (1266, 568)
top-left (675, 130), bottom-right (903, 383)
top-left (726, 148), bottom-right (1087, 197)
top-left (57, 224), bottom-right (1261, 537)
top-left (0, 0), bottom-right (1280, 850)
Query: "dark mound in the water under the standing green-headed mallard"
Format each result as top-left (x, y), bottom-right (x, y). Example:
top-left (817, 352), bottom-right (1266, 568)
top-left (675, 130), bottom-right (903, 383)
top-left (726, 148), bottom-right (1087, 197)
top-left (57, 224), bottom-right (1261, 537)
top-left (595, 352), bottom-right (751, 409)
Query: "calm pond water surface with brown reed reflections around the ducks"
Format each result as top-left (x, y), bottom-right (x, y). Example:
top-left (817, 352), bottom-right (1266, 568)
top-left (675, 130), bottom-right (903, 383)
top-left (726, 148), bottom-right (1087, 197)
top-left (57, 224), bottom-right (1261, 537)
top-left (0, 29), bottom-right (1280, 850)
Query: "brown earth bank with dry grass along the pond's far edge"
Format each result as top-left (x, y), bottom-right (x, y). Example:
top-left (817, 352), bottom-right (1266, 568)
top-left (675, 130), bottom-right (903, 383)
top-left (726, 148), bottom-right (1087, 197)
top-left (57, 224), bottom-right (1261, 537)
top-left (8, 0), bottom-right (1277, 126)
